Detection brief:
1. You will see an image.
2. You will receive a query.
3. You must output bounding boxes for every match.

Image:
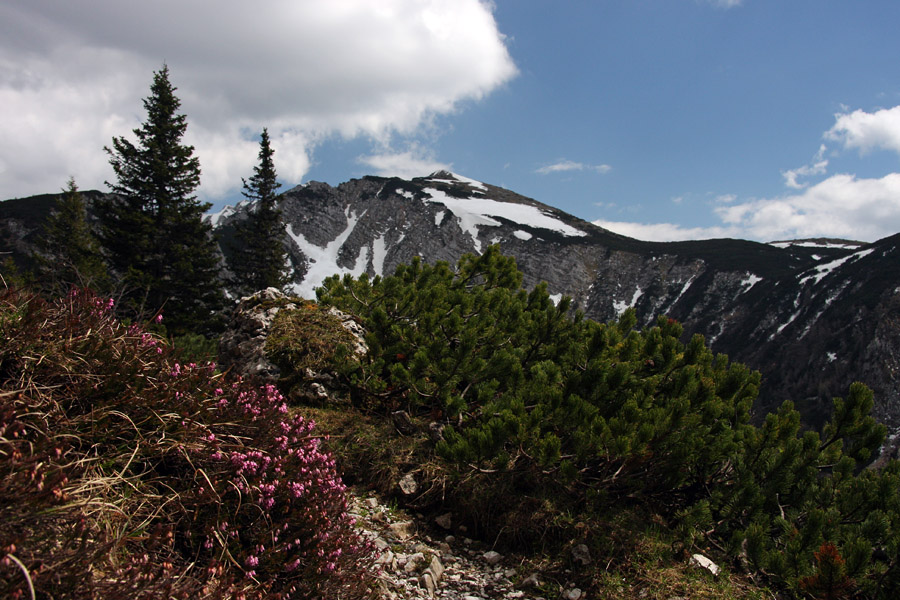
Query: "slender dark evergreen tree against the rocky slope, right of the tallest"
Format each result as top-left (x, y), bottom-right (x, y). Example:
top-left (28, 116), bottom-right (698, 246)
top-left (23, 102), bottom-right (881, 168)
top-left (229, 129), bottom-right (290, 294)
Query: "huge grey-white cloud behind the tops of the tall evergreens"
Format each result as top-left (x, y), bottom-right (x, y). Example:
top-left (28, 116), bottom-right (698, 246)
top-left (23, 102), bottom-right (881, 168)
top-left (0, 0), bottom-right (517, 197)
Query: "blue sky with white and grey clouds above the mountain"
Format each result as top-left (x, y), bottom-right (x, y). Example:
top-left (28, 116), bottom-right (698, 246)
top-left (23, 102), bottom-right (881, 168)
top-left (0, 0), bottom-right (900, 241)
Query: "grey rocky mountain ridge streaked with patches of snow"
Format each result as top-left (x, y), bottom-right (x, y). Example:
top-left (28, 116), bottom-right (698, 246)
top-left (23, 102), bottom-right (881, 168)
top-left (0, 172), bottom-right (900, 438)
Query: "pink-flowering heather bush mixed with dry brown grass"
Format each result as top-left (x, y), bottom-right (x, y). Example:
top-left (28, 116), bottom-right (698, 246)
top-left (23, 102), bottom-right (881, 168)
top-left (0, 291), bottom-right (371, 599)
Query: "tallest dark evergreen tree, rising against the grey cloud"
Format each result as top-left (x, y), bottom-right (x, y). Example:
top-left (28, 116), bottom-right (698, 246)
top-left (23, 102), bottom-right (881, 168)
top-left (99, 65), bottom-right (223, 334)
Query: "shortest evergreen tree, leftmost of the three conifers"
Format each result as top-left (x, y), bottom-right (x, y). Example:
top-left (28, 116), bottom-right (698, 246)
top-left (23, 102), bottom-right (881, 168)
top-left (35, 178), bottom-right (108, 291)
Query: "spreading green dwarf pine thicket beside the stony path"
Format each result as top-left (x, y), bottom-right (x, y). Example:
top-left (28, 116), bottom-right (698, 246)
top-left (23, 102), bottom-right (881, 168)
top-left (319, 247), bottom-right (900, 598)
